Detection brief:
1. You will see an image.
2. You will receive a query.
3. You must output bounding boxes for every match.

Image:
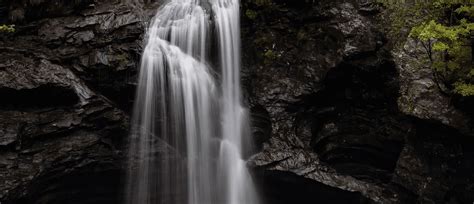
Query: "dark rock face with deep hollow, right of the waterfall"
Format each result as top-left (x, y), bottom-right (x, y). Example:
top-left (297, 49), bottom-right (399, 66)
top-left (243, 1), bottom-right (474, 203)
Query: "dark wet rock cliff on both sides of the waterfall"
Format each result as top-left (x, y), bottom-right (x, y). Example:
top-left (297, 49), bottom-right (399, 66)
top-left (0, 0), bottom-right (474, 204)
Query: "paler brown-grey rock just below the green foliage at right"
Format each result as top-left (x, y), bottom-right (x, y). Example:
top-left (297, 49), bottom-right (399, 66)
top-left (394, 40), bottom-right (472, 132)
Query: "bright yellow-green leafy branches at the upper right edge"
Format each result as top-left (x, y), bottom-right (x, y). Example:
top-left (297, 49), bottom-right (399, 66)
top-left (409, 2), bottom-right (474, 96)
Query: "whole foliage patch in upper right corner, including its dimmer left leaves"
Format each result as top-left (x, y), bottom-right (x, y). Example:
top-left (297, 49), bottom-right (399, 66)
top-left (377, 0), bottom-right (474, 96)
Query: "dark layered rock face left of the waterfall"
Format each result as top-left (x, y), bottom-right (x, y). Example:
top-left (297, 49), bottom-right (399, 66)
top-left (0, 0), bottom-right (158, 204)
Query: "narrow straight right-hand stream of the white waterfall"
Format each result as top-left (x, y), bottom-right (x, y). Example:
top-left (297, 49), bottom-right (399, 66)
top-left (212, 0), bottom-right (257, 204)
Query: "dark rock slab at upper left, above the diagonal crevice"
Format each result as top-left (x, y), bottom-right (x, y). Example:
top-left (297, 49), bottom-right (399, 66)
top-left (2, 0), bottom-right (159, 111)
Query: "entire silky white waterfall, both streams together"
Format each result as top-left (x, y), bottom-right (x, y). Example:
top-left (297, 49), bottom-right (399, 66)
top-left (126, 0), bottom-right (259, 204)
